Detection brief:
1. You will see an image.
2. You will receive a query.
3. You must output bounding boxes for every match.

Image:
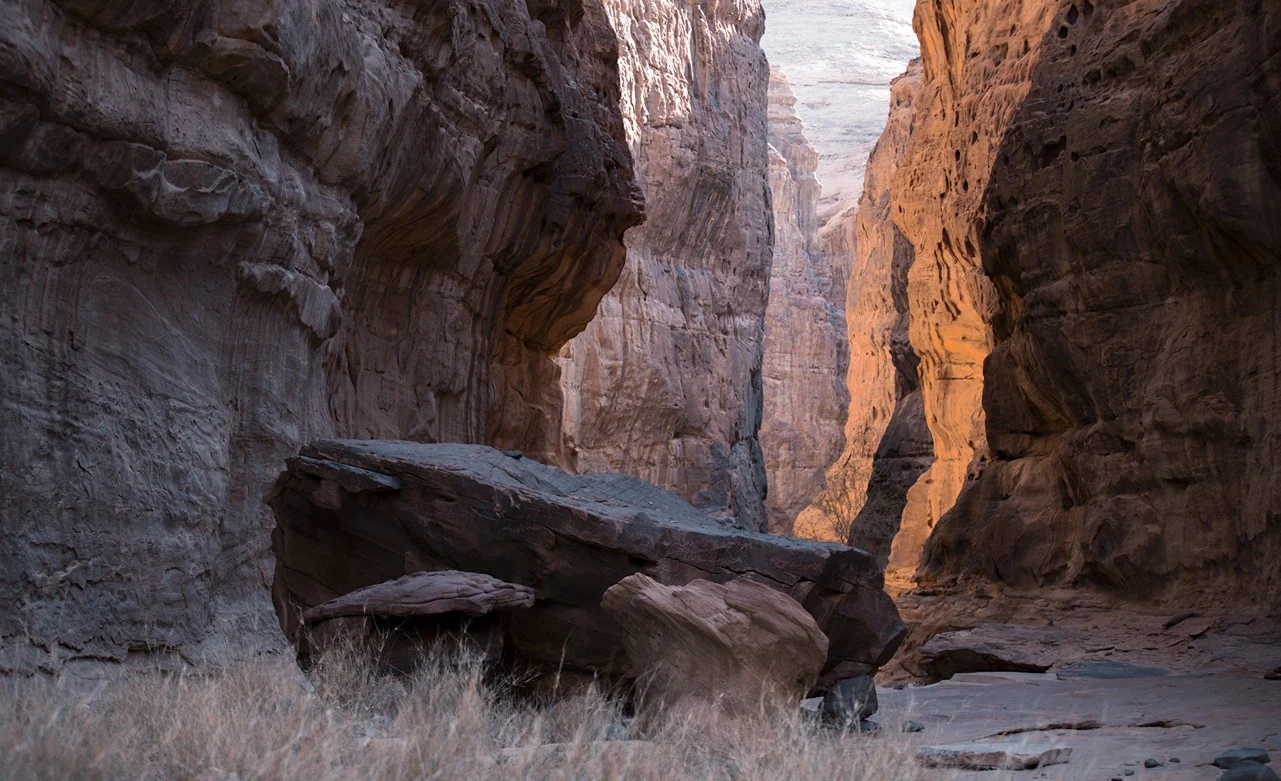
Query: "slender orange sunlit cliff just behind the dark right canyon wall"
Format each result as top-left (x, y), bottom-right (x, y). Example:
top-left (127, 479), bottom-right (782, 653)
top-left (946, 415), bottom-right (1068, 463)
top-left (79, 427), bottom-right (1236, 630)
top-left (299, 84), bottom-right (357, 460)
top-left (797, 60), bottom-right (933, 558)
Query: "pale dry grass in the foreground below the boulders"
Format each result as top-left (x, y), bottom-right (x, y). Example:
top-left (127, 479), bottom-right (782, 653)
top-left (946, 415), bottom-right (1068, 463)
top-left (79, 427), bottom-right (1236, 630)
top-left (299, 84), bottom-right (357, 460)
top-left (0, 645), bottom-right (942, 781)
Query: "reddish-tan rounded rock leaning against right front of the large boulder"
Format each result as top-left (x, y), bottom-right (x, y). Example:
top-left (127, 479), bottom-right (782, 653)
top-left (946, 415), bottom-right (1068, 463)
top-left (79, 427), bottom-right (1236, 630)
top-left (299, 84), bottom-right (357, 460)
top-left (603, 574), bottom-right (824, 716)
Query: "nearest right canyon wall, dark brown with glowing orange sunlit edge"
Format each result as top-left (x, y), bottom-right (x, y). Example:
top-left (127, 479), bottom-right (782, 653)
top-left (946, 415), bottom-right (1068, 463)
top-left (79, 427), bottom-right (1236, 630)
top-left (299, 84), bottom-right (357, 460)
top-left (860, 0), bottom-right (1281, 601)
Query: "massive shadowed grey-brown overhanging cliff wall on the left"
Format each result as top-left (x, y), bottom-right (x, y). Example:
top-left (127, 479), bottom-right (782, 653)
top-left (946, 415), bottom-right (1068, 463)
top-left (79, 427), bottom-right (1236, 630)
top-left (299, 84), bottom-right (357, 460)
top-left (0, 0), bottom-right (640, 670)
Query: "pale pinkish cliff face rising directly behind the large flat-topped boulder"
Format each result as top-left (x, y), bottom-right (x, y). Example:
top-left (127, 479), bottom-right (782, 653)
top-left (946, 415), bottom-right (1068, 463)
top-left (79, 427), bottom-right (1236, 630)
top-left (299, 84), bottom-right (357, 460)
top-left (559, 0), bottom-right (771, 530)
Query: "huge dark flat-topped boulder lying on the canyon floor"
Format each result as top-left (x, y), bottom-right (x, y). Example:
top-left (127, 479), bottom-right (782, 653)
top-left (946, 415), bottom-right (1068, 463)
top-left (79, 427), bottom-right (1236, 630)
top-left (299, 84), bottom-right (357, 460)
top-left (266, 440), bottom-right (904, 688)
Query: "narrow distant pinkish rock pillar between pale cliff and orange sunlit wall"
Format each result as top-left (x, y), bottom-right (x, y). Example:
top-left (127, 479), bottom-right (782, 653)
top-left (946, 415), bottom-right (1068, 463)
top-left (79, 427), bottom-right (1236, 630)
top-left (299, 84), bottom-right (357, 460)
top-left (760, 68), bottom-right (849, 532)
